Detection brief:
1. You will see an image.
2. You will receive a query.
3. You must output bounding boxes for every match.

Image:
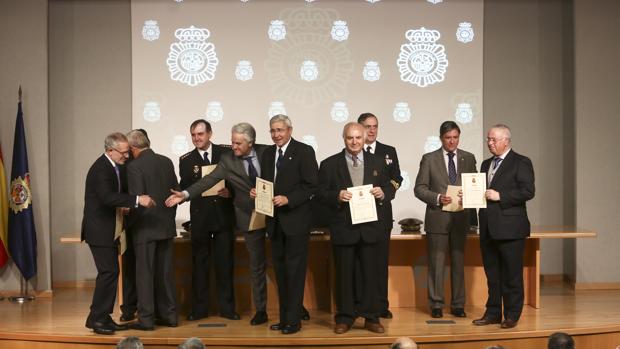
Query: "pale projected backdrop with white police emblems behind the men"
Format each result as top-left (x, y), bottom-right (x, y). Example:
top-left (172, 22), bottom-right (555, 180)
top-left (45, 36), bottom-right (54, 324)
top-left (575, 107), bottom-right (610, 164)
top-left (131, 0), bottom-right (483, 226)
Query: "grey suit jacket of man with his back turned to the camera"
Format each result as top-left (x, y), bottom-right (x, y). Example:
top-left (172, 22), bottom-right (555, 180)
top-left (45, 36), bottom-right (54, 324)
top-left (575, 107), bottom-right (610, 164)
top-left (127, 149), bottom-right (179, 243)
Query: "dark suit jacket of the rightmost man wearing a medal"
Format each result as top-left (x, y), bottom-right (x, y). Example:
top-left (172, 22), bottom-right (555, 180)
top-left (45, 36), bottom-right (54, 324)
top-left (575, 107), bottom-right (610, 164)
top-left (479, 150), bottom-right (536, 240)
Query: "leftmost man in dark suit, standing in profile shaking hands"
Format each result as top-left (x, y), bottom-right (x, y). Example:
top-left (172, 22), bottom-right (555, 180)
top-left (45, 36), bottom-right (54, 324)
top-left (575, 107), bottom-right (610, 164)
top-left (82, 133), bottom-right (154, 334)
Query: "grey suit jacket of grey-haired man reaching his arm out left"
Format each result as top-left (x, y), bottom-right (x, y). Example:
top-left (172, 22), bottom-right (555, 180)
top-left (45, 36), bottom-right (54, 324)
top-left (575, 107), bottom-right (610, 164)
top-left (185, 144), bottom-right (268, 231)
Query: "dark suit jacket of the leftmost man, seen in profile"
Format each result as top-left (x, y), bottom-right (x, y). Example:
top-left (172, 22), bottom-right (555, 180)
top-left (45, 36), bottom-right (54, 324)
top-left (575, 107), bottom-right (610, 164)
top-left (81, 155), bottom-right (136, 247)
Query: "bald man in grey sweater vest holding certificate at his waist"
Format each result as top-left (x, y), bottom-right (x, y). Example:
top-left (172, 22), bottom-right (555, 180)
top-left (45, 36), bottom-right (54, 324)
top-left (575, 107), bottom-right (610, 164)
top-left (318, 122), bottom-right (395, 334)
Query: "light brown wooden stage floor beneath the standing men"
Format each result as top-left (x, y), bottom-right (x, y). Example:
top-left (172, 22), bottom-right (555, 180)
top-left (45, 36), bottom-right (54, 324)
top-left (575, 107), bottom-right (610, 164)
top-left (0, 284), bottom-right (620, 349)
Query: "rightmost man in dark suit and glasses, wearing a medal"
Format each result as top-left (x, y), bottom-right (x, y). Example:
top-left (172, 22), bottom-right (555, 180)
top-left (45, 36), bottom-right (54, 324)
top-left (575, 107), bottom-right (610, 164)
top-left (473, 124), bottom-right (535, 328)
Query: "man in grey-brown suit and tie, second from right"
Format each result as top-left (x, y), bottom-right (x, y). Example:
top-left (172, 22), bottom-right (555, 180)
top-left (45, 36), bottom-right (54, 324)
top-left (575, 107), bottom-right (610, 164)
top-left (413, 121), bottom-right (476, 318)
